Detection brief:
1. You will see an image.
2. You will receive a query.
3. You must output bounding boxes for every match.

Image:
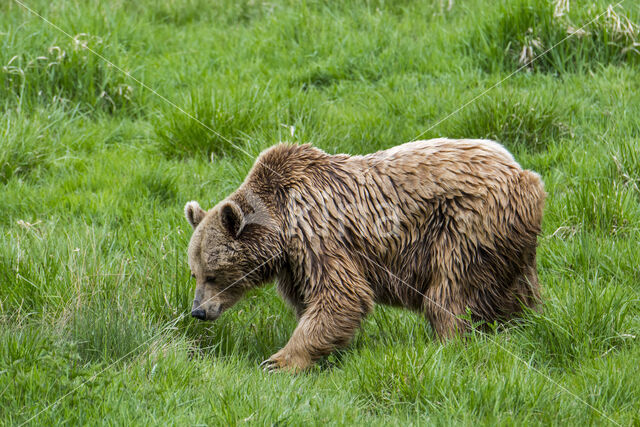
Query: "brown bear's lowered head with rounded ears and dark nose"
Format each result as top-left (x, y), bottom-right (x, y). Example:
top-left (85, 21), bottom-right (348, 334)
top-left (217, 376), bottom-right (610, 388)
top-left (184, 200), bottom-right (281, 320)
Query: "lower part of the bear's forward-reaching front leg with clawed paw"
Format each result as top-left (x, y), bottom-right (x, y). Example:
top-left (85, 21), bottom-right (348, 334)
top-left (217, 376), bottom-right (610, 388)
top-left (261, 294), bottom-right (373, 372)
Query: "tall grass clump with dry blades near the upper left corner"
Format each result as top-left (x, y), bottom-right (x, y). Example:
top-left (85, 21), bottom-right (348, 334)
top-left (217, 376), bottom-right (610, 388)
top-left (0, 29), bottom-right (137, 114)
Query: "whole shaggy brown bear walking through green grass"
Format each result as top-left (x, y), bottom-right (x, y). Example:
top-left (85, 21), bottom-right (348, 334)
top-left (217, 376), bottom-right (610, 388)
top-left (185, 139), bottom-right (546, 371)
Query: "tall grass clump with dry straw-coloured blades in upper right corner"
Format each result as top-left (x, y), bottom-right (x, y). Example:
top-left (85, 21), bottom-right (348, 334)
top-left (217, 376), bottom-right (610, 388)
top-left (465, 0), bottom-right (640, 74)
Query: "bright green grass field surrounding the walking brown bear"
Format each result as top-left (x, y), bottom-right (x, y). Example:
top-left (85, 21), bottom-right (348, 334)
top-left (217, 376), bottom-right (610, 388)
top-left (0, 0), bottom-right (640, 425)
